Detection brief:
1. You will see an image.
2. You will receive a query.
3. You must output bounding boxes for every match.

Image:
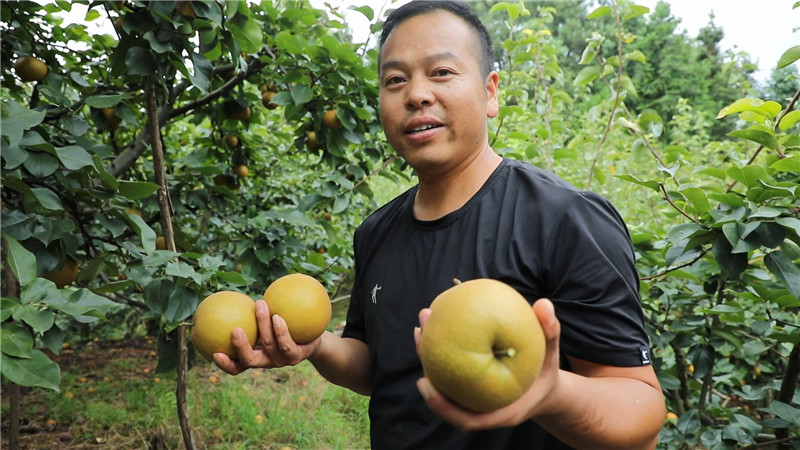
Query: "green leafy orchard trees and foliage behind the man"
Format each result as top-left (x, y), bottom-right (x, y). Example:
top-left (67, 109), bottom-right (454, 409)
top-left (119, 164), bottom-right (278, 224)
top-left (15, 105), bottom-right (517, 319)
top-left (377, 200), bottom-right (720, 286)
top-left (0, 0), bottom-right (800, 448)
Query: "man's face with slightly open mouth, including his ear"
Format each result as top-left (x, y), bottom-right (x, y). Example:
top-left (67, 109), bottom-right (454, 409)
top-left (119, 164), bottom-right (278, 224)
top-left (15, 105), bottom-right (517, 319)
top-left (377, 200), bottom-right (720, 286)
top-left (379, 11), bottom-right (498, 176)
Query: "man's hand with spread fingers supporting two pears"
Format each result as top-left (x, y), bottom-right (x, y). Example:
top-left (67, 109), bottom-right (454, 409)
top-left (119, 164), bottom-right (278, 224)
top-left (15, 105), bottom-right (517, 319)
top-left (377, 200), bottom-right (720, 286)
top-left (214, 300), bottom-right (325, 375)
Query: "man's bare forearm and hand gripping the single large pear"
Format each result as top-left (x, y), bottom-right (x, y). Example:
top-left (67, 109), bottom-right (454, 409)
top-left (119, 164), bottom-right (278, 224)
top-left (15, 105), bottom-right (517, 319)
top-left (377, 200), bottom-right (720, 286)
top-left (415, 299), bottom-right (665, 449)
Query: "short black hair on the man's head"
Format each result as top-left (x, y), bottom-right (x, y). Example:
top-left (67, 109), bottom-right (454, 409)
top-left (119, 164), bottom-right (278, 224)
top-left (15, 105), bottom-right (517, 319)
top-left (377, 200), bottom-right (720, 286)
top-left (378, 0), bottom-right (494, 76)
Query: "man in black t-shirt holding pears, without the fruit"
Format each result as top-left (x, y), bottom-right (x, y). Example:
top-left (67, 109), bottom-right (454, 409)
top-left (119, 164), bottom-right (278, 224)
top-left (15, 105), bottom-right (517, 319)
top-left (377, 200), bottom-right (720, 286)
top-left (215, 1), bottom-right (664, 449)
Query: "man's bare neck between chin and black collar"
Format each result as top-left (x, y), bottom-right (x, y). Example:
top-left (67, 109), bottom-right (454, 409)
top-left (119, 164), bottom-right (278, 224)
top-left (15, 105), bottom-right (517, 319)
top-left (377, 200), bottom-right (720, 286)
top-left (414, 146), bottom-right (503, 220)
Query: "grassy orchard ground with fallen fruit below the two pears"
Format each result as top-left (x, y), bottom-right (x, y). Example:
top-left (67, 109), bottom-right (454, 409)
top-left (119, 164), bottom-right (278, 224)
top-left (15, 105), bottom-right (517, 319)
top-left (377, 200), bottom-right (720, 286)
top-left (0, 300), bottom-right (369, 449)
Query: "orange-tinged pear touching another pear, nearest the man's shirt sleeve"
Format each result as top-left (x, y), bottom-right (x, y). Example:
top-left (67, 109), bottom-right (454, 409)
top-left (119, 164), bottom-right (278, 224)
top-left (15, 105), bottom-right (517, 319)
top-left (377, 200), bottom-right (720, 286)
top-left (264, 273), bottom-right (331, 344)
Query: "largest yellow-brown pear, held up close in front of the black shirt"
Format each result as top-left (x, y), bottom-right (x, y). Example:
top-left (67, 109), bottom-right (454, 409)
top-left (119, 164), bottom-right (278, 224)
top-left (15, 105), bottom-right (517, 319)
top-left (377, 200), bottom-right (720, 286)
top-left (420, 278), bottom-right (545, 412)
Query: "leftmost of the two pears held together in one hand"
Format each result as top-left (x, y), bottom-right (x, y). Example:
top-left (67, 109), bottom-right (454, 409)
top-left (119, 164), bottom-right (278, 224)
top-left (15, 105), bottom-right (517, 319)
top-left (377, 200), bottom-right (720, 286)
top-left (191, 291), bottom-right (258, 360)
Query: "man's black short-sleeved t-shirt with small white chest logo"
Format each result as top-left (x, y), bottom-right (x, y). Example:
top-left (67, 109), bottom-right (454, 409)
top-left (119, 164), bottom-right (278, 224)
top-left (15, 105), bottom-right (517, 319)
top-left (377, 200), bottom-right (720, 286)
top-left (343, 159), bottom-right (650, 449)
